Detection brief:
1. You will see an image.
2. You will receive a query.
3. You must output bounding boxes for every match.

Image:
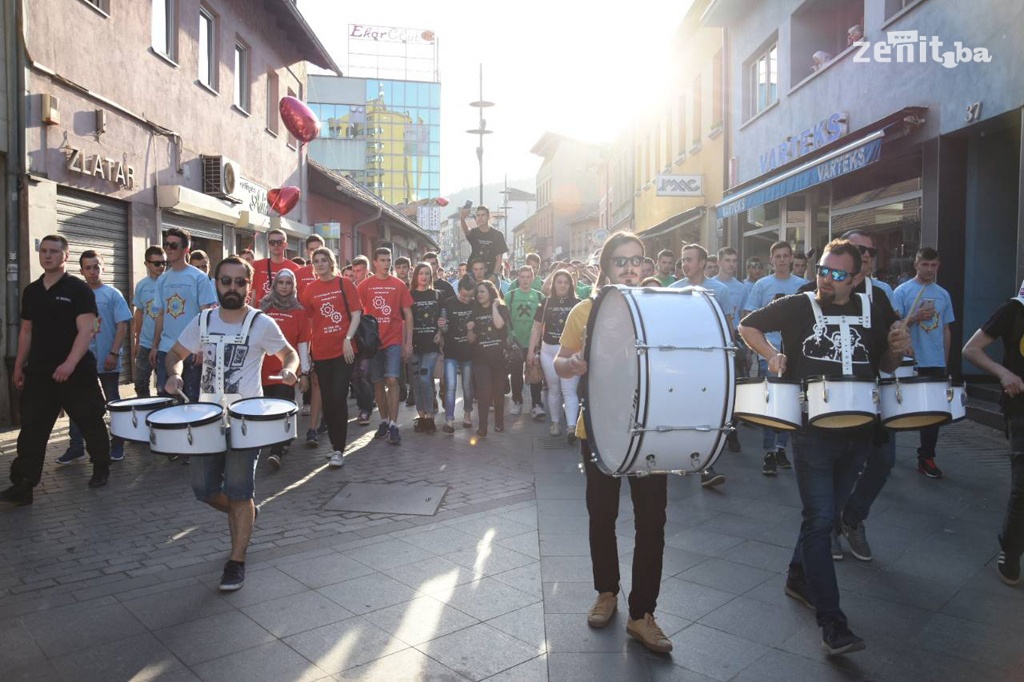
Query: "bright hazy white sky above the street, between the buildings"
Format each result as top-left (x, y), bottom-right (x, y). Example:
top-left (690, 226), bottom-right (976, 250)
top-left (298, 0), bottom-right (690, 195)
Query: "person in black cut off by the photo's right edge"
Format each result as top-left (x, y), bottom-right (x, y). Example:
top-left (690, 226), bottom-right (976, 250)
top-left (964, 298), bottom-right (1024, 585)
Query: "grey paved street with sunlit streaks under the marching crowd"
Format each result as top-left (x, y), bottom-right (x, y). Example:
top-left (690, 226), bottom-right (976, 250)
top-left (0, 401), bottom-right (1024, 682)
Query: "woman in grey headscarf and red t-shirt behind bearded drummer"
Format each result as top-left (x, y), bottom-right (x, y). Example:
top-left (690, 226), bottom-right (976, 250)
top-left (259, 269), bottom-right (309, 469)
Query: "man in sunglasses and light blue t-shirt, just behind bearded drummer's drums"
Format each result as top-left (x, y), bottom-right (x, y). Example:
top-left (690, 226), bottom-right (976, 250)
top-left (150, 227), bottom-right (217, 409)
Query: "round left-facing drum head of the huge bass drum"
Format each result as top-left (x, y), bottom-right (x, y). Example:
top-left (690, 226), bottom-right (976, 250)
top-left (585, 287), bottom-right (640, 471)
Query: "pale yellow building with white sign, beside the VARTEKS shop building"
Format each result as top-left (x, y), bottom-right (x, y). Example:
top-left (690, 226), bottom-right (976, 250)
top-left (633, 0), bottom-right (728, 258)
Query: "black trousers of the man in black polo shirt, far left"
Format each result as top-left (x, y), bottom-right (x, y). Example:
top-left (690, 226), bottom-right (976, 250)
top-left (10, 364), bottom-right (111, 486)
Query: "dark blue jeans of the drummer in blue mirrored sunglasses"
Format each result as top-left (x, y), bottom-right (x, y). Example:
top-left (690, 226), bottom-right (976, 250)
top-left (790, 428), bottom-right (873, 626)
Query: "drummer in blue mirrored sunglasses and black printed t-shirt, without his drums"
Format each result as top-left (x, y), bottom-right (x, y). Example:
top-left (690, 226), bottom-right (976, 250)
top-left (739, 240), bottom-right (910, 654)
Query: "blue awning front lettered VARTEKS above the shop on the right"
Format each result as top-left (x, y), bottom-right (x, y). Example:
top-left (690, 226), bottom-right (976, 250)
top-left (716, 130), bottom-right (886, 220)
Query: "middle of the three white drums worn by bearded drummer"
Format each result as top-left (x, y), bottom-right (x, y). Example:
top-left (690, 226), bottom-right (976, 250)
top-left (145, 402), bottom-right (227, 457)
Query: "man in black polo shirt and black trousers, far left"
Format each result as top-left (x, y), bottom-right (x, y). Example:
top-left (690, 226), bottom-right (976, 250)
top-left (0, 235), bottom-right (111, 505)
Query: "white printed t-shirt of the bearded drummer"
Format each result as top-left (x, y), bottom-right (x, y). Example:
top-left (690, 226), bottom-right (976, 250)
top-left (178, 308), bottom-right (288, 397)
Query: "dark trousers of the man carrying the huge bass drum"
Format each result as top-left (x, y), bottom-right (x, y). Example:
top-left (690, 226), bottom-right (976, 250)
top-left (580, 439), bottom-right (669, 621)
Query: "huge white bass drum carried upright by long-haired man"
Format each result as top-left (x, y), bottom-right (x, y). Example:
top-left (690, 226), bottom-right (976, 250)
top-left (583, 286), bottom-right (735, 476)
